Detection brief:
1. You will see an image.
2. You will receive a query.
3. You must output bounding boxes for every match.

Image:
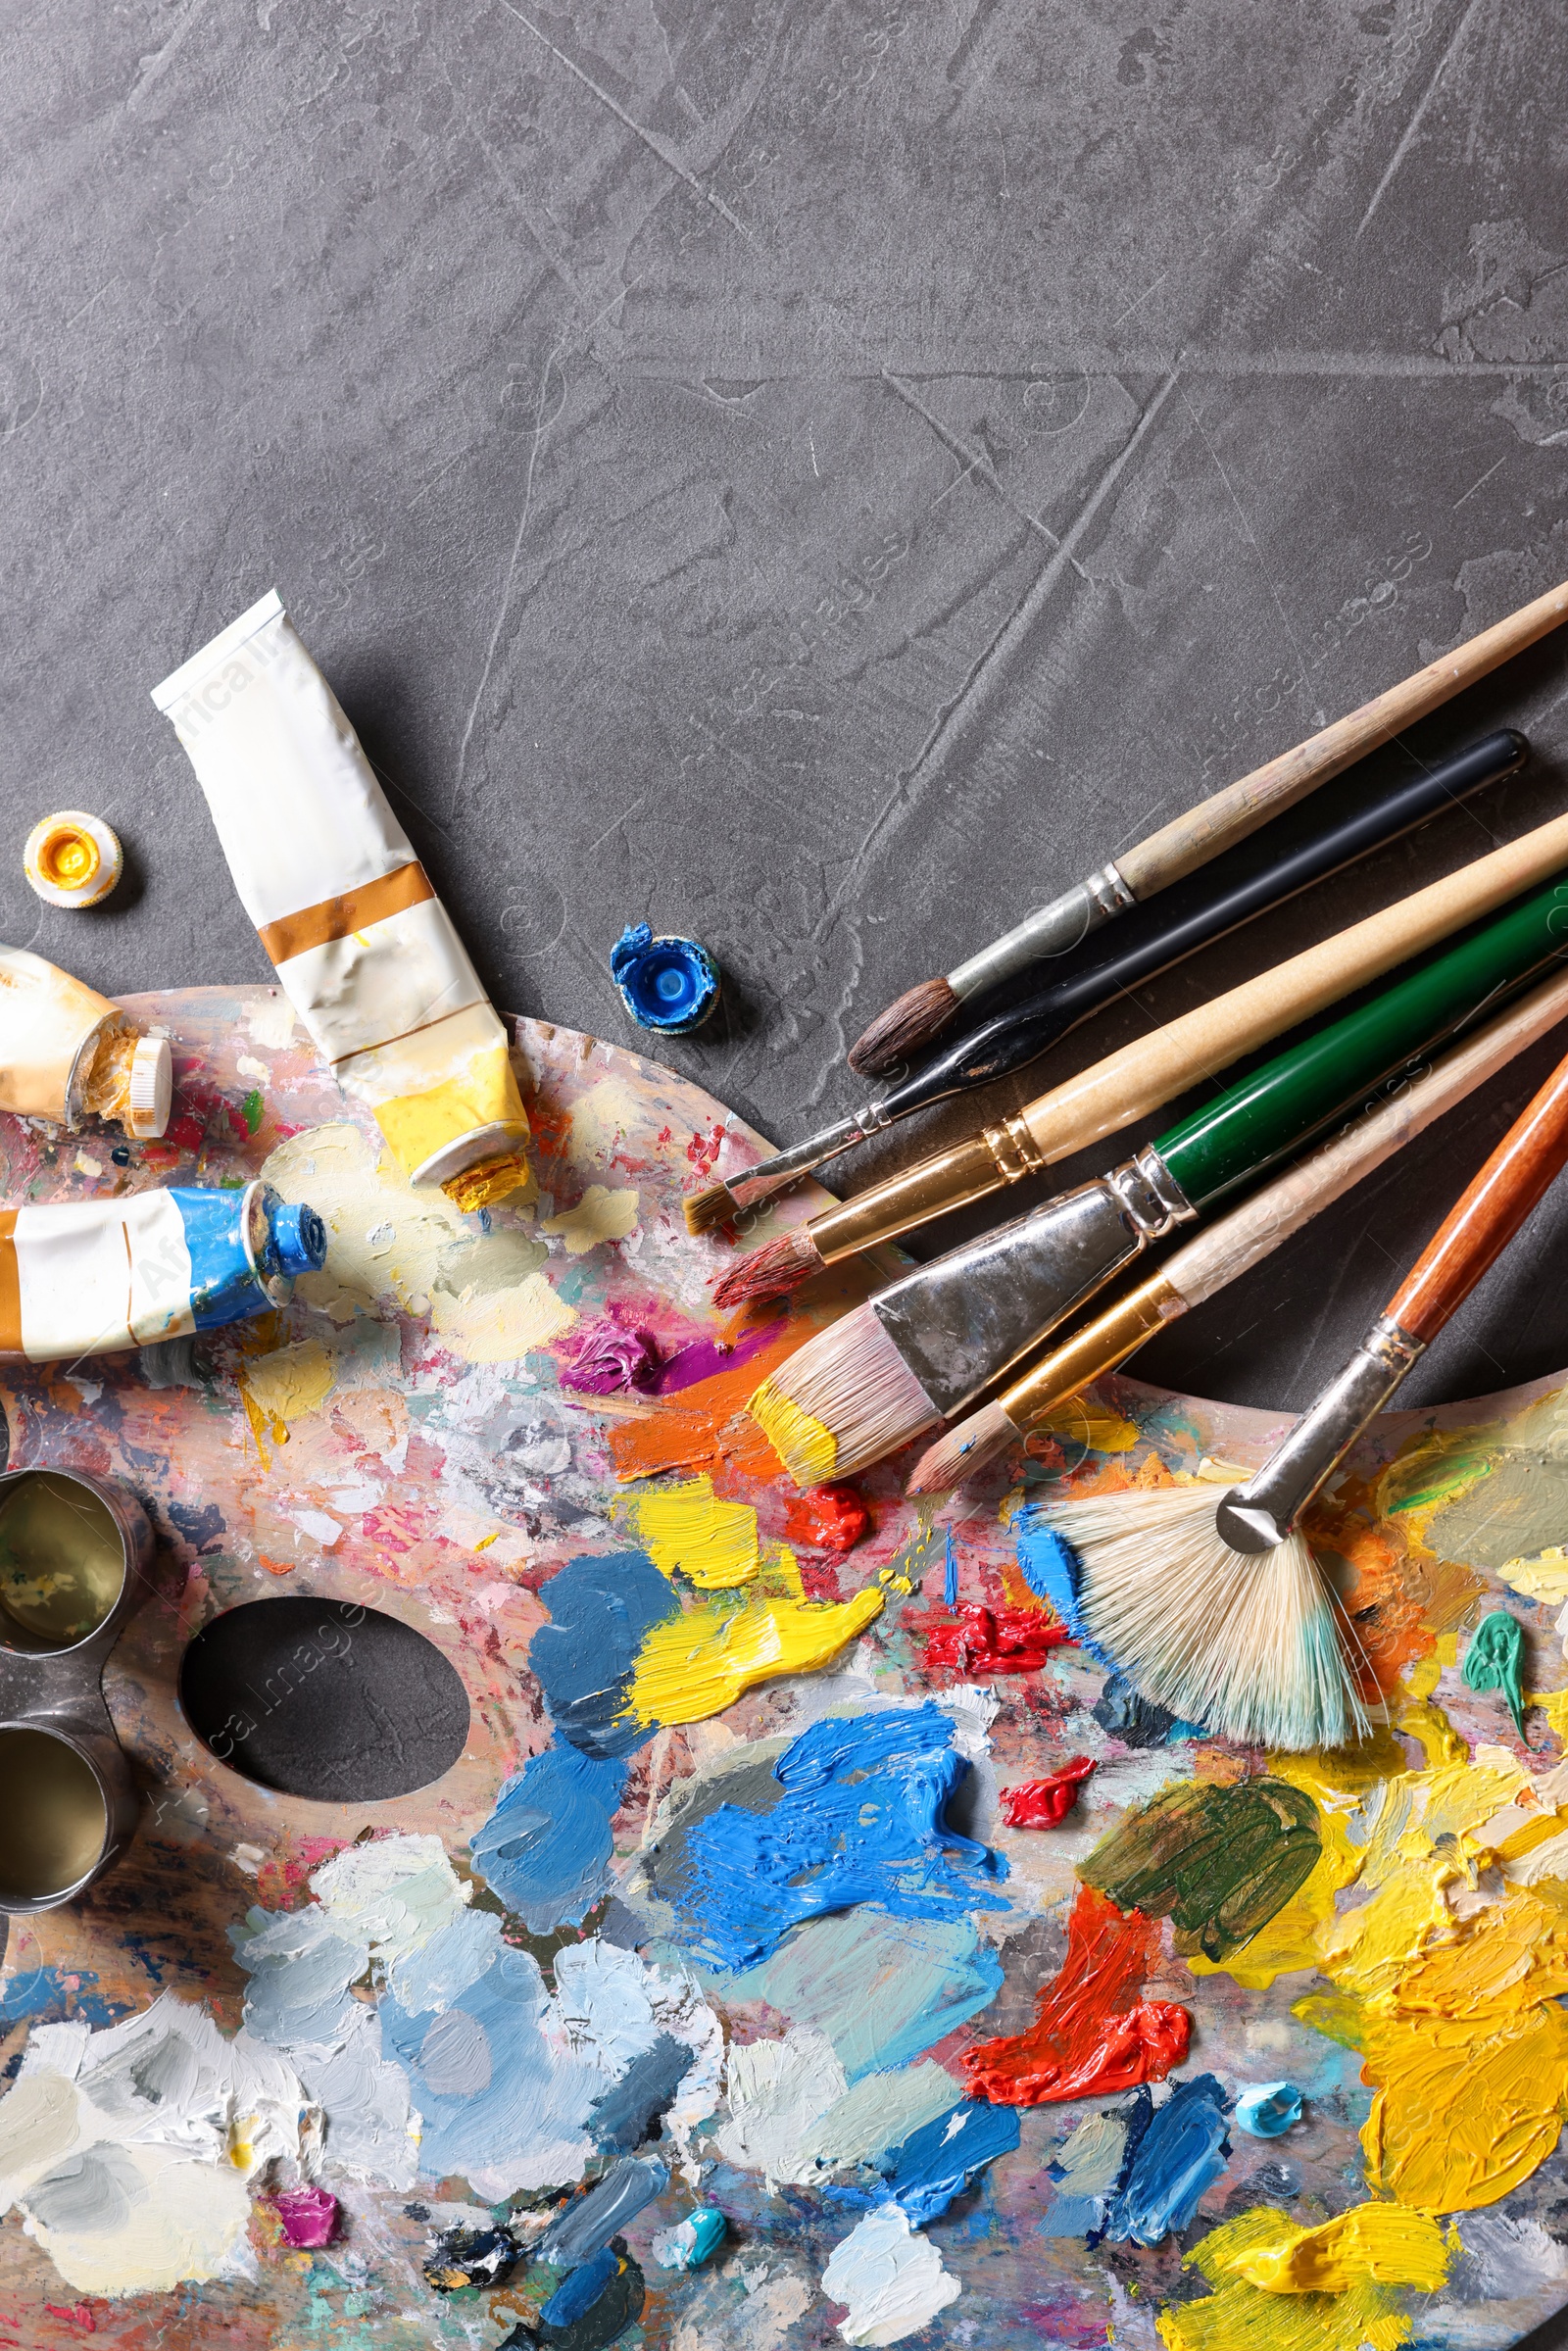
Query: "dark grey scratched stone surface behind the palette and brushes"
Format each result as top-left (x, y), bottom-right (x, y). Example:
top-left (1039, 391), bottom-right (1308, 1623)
top-left (0, 0), bottom-right (1568, 1408)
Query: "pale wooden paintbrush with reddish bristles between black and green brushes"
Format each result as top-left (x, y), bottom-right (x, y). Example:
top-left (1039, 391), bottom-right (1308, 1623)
top-left (714, 815), bottom-right (1568, 1307)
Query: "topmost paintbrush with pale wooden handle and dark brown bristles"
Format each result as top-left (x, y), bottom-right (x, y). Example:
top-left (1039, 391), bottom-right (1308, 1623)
top-left (849, 583), bottom-right (1568, 1077)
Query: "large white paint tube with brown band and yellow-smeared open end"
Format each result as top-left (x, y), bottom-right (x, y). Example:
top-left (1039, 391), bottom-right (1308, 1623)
top-left (153, 595), bottom-right (529, 1208)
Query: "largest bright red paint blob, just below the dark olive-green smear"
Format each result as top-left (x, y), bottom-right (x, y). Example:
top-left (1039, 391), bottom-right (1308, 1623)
top-left (964, 1886), bottom-right (1192, 2107)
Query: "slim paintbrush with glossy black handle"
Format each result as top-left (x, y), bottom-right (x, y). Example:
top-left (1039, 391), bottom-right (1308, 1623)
top-left (682, 731), bottom-right (1531, 1234)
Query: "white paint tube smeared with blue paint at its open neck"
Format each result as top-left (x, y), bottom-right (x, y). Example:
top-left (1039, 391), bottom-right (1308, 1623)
top-left (0, 1183), bottom-right (326, 1363)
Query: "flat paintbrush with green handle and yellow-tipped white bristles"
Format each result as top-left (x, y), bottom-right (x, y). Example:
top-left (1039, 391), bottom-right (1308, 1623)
top-left (745, 882), bottom-right (1568, 1486)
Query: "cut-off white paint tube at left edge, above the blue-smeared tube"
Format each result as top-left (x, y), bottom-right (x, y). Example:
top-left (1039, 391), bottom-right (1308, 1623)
top-left (0, 948), bottom-right (174, 1143)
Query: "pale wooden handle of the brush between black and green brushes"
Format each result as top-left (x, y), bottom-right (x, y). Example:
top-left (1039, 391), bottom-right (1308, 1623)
top-left (1024, 815), bottom-right (1568, 1165)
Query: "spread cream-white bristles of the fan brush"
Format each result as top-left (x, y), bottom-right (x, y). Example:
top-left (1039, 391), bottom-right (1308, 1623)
top-left (1046, 1486), bottom-right (1368, 1749)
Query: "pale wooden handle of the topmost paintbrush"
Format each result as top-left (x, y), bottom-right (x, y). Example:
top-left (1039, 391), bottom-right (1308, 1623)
top-left (1116, 581), bottom-right (1568, 898)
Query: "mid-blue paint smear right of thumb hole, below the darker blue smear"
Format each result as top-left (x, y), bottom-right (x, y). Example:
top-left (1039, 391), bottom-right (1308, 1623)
top-left (470, 1746), bottom-right (625, 1935)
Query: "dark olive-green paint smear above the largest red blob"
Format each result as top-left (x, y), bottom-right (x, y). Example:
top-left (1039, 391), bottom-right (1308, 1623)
top-left (1079, 1780), bottom-right (1324, 1961)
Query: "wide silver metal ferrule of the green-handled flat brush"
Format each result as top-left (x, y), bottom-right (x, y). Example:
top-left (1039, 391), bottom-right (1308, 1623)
top-left (870, 1150), bottom-right (1197, 1420)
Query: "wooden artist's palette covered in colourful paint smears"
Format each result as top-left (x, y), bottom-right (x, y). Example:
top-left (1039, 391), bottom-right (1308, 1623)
top-left (0, 988), bottom-right (1568, 2351)
